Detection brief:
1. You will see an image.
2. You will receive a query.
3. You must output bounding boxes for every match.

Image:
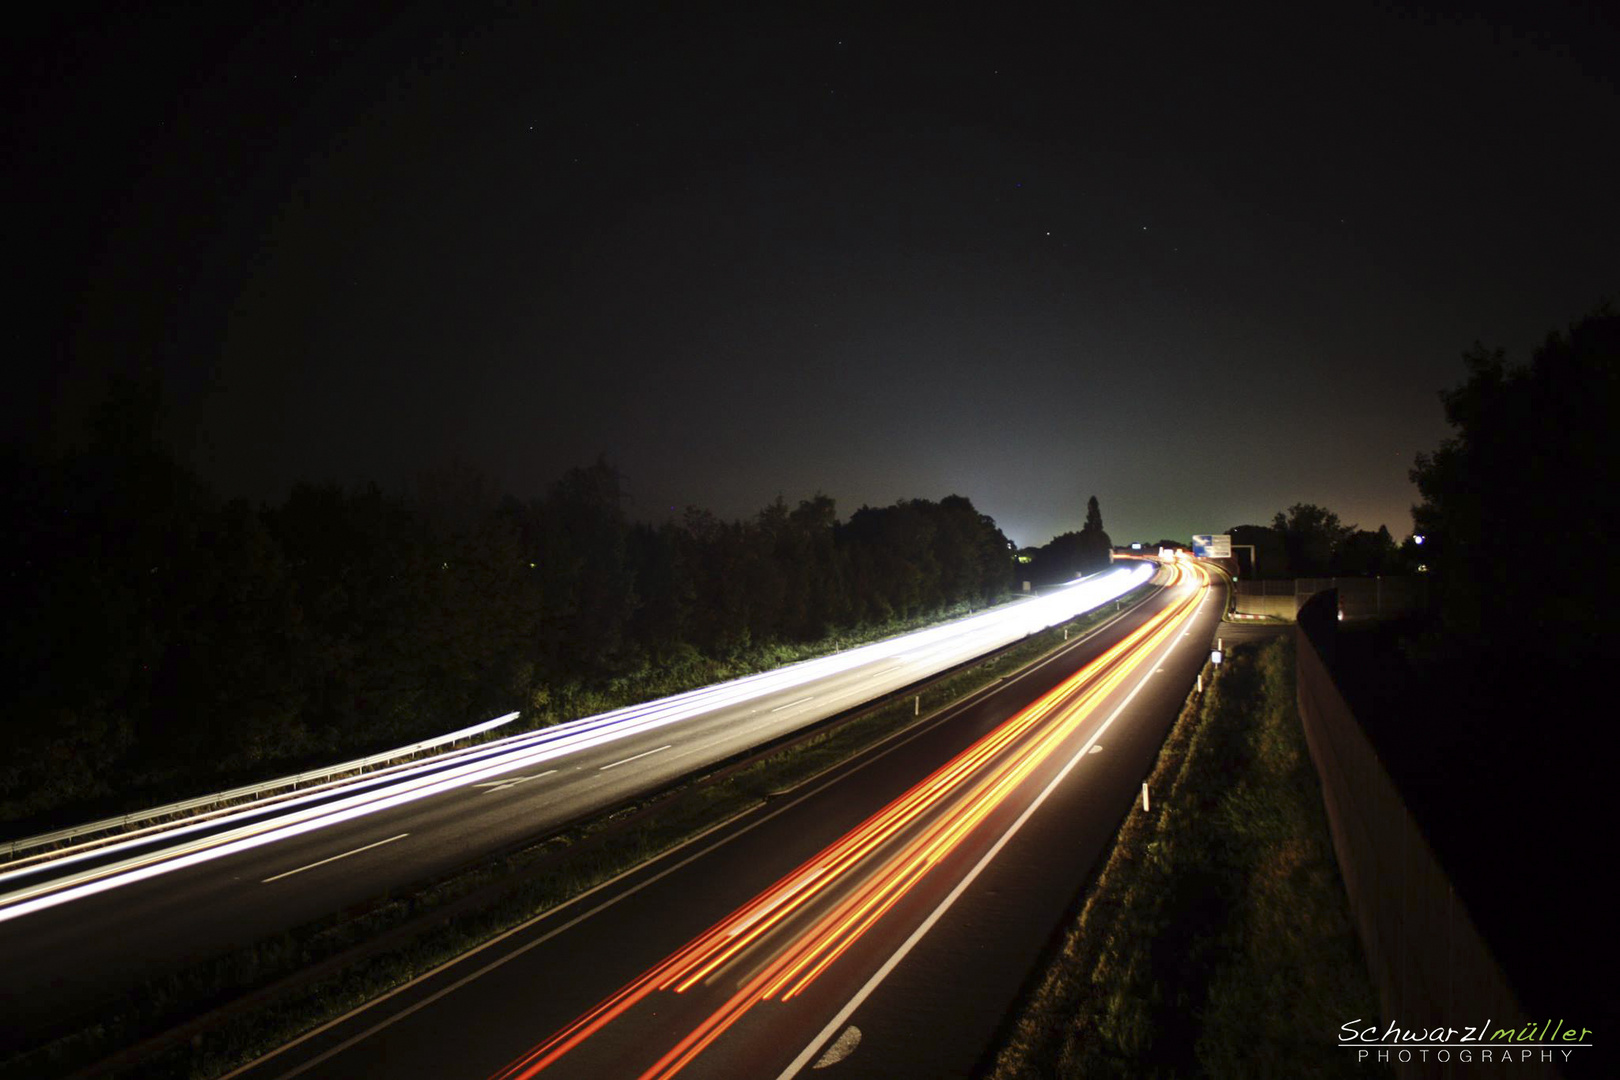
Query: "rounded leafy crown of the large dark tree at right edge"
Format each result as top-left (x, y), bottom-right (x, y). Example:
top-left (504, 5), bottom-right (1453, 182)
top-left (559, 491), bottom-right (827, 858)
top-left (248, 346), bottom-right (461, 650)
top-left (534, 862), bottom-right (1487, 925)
top-left (1411, 306), bottom-right (1620, 661)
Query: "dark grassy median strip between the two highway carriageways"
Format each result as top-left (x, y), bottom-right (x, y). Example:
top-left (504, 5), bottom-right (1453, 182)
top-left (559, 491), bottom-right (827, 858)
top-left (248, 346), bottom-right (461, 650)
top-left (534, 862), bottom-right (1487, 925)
top-left (0, 585), bottom-right (1153, 1080)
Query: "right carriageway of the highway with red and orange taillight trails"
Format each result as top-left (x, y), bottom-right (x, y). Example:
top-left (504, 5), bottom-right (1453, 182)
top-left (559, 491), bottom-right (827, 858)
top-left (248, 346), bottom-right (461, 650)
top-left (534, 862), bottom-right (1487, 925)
top-left (234, 570), bottom-right (1220, 1077)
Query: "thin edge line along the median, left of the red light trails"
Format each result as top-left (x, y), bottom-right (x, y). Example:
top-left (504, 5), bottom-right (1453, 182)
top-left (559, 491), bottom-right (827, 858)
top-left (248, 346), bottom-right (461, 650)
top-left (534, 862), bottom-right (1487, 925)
top-left (217, 586), bottom-right (1163, 1080)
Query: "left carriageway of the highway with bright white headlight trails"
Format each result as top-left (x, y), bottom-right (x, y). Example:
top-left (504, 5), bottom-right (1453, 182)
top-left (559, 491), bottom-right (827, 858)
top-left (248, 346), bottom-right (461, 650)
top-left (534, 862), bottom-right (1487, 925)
top-left (0, 566), bottom-right (1153, 1041)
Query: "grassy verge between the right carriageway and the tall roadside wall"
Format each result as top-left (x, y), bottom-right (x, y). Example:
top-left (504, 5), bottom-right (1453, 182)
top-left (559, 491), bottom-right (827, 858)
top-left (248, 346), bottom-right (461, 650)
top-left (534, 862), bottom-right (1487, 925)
top-left (988, 638), bottom-right (1377, 1080)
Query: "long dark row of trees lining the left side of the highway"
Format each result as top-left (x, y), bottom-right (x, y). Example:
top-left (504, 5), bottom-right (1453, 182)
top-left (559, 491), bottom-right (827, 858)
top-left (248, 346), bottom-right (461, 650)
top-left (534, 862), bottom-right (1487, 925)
top-left (0, 381), bottom-right (1013, 824)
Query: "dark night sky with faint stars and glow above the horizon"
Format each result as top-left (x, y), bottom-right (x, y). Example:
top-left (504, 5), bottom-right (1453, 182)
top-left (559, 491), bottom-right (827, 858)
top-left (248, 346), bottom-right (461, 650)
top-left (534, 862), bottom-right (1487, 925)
top-left (5, 3), bottom-right (1620, 544)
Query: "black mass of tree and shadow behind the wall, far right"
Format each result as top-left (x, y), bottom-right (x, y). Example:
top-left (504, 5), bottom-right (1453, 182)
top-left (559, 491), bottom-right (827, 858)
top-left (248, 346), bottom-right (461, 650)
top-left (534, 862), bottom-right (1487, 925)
top-left (1315, 308), bottom-right (1620, 1036)
